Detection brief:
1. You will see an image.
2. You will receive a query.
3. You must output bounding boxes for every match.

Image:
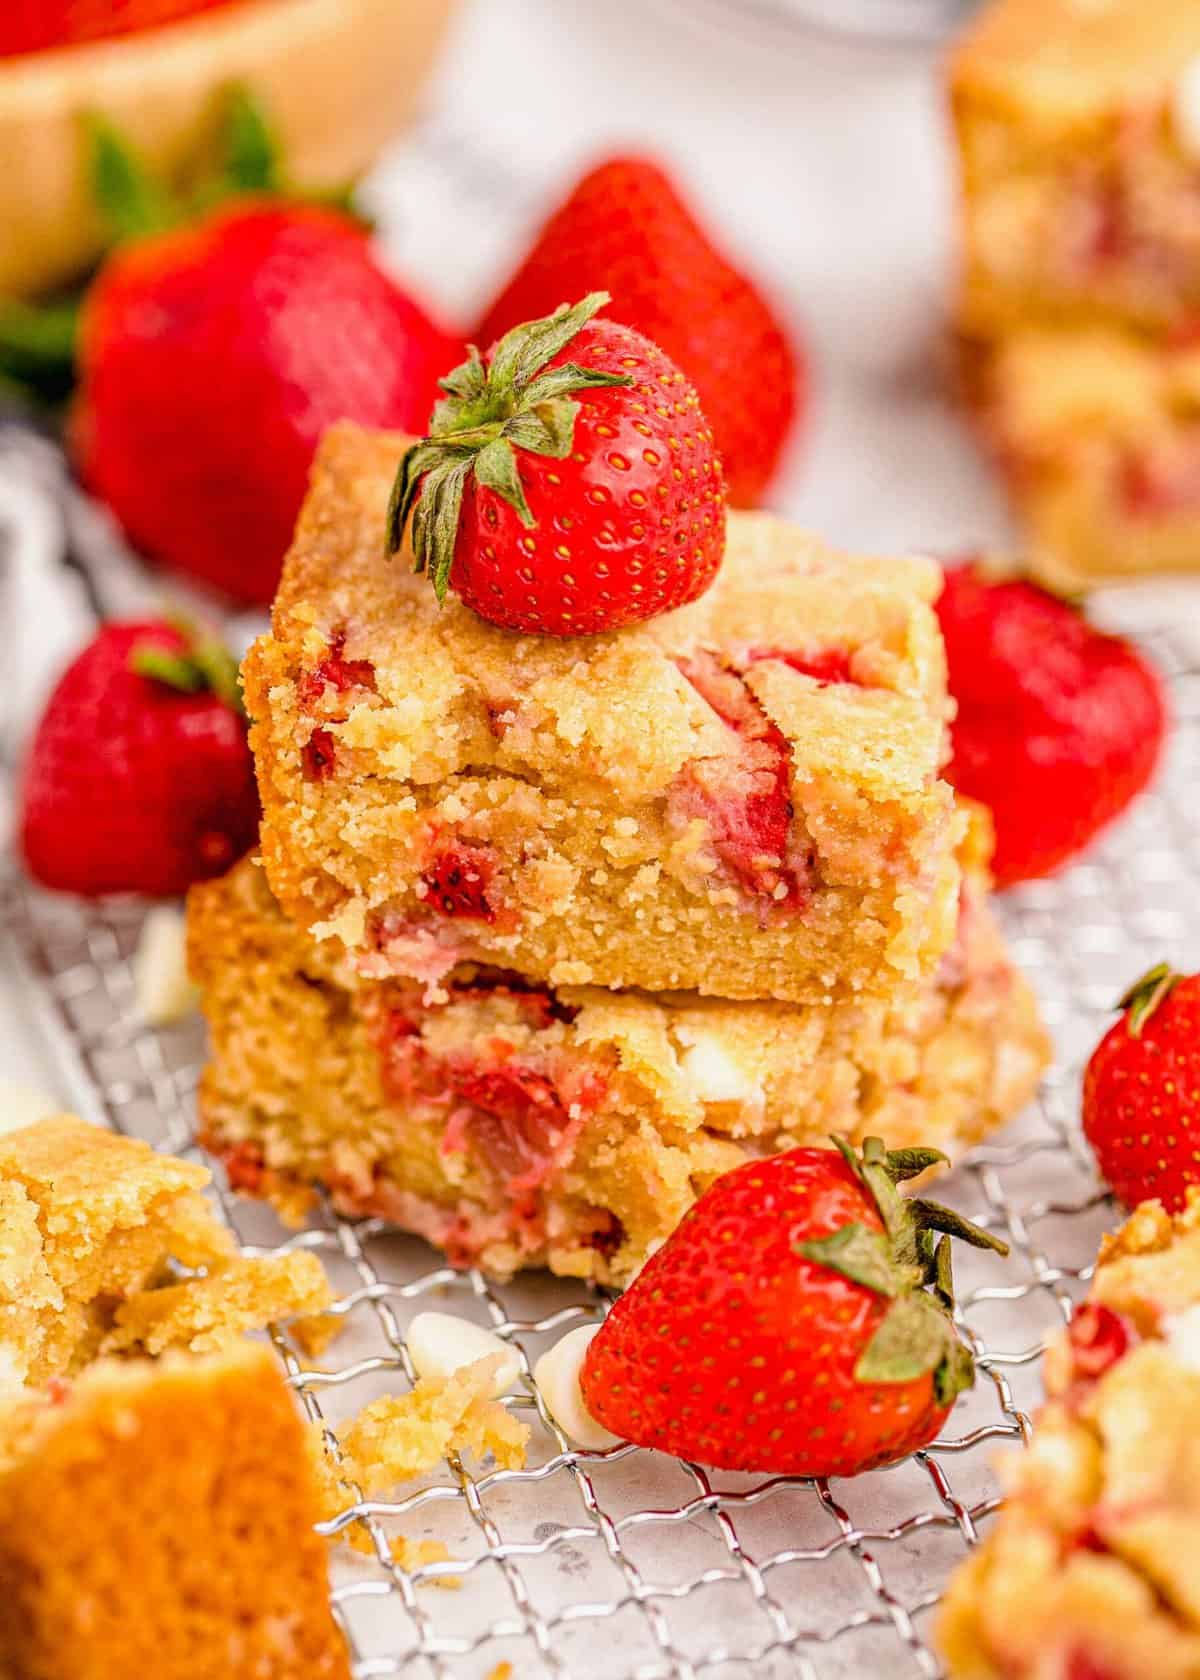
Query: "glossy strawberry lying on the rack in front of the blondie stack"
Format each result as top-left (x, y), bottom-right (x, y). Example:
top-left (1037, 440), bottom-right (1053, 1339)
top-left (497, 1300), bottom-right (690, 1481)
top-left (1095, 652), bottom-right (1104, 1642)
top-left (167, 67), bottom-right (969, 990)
top-left (582, 1137), bottom-right (1007, 1475)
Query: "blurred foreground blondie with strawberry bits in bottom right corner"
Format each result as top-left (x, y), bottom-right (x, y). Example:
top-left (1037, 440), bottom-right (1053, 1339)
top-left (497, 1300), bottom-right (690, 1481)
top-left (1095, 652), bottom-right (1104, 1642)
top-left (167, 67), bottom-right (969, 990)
top-left (939, 1189), bottom-right (1200, 1680)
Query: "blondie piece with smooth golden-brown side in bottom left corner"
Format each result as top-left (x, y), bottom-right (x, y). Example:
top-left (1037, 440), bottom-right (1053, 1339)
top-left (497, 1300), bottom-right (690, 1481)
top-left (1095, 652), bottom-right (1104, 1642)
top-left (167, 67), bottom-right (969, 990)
top-left (0, 1344), bottom-right (350, 1680)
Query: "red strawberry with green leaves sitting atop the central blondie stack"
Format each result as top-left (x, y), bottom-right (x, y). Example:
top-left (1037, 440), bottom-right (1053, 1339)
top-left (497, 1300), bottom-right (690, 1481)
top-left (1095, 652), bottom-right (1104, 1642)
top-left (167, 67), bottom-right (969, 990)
top-left (388, 292), bottom-right (724, 635)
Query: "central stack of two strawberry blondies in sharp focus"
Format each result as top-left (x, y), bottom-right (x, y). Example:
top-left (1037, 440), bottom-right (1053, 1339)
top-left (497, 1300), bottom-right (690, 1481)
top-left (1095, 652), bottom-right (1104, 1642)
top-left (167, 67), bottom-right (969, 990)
top-left (190, 425), bottom-right (1047, 1284)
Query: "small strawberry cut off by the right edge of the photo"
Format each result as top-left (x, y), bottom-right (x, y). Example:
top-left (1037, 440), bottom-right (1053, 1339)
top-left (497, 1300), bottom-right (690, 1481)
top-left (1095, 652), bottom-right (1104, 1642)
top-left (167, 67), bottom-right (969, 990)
top-left (1082, 963), bottom-right (1200, 1213)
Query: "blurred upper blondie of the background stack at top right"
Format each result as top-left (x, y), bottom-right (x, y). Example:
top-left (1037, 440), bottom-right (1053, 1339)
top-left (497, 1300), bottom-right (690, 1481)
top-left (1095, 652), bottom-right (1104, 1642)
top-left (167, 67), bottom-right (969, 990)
top-left (950, 0), bottom-right (1200, 334)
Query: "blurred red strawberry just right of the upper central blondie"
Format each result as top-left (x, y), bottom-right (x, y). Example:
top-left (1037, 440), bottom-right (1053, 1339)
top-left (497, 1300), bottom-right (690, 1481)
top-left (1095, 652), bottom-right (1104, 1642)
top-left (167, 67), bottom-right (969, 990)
top-left (938, 564), bottom-right (1166, 887)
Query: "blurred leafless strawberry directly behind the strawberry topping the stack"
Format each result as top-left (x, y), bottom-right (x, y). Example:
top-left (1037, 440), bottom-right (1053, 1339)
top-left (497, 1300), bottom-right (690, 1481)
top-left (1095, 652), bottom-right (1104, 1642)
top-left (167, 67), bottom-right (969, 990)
top-left (476, 158), bottom-right (805, 507)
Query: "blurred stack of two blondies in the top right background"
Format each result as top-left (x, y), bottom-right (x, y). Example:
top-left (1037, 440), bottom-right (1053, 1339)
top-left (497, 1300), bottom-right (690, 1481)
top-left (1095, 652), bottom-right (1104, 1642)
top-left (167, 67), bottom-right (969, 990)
top-left (950, 0), bottom-right (1200, 585)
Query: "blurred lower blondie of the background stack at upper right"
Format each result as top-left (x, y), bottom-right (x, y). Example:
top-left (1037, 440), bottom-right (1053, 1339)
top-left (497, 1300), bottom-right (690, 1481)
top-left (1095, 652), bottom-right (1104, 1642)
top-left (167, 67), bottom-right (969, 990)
top-left (965, 324), bottom-right (1200, 590)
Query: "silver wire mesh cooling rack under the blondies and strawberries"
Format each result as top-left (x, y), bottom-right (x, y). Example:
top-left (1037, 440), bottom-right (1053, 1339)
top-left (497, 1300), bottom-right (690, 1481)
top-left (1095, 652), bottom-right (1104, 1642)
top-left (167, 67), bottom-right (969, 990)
top-left (0, 604), bottom-right (1200, 1680)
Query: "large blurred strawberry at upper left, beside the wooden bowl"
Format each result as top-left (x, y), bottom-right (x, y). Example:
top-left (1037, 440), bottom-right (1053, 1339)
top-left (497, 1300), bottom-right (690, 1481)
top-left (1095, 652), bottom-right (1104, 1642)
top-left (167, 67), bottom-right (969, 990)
top-left (76, 202), bottom-right (457, 601)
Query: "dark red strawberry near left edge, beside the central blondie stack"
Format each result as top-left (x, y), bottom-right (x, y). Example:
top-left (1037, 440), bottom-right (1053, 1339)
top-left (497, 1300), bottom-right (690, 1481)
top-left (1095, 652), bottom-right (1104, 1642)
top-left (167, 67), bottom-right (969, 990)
top-left (20, 620), bottom-right (259, 895)
